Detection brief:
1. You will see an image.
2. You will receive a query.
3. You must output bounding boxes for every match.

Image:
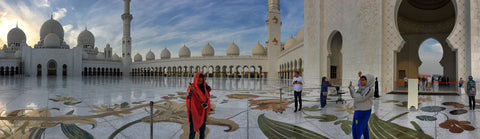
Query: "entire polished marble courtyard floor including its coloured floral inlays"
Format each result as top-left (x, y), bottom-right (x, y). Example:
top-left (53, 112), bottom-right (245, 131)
top-left (0, 77), bottom-right (480, 139)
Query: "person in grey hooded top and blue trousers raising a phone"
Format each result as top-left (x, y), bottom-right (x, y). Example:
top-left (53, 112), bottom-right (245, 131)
top-left (348, 74), bottom-right (374, 139)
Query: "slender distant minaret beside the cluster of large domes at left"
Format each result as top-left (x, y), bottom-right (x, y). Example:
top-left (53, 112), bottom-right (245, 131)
top-left (122, 0), bottom-right (133, 75)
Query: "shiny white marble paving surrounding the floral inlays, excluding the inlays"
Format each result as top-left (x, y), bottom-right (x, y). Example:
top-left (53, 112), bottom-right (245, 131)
top-left (0, 76), bottom-right (480, 138)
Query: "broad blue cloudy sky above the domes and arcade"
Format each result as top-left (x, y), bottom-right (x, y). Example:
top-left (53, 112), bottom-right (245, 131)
top-left (0, 0), bottom-right (304, 59)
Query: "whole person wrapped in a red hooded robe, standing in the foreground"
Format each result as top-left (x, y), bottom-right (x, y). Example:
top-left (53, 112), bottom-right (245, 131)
top-left (185, 72), bottom-right (211, 139)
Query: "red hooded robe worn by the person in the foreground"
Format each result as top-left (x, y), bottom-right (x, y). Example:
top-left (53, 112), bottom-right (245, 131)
top-left (185, 72), bottom-right (210, 132)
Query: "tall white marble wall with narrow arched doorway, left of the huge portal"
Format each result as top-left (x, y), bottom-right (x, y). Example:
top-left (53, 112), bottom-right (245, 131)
top-left (305, 0), bottom-right (382, 85)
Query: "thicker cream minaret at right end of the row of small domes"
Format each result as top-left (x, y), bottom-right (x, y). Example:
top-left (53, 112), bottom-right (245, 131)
top-left (265, 0), bottom-right (282, 80)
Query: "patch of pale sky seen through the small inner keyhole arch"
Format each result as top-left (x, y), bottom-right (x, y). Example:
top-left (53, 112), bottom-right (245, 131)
top-left (418, 39), bottom-right (443, 75)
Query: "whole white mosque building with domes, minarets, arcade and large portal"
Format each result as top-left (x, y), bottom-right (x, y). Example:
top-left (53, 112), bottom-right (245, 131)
top-left (0, 0), bottom-right (480, 92)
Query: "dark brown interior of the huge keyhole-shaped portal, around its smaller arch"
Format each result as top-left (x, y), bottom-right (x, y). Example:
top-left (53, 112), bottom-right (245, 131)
top-left (395, 0), bottom-right (457, 90)
